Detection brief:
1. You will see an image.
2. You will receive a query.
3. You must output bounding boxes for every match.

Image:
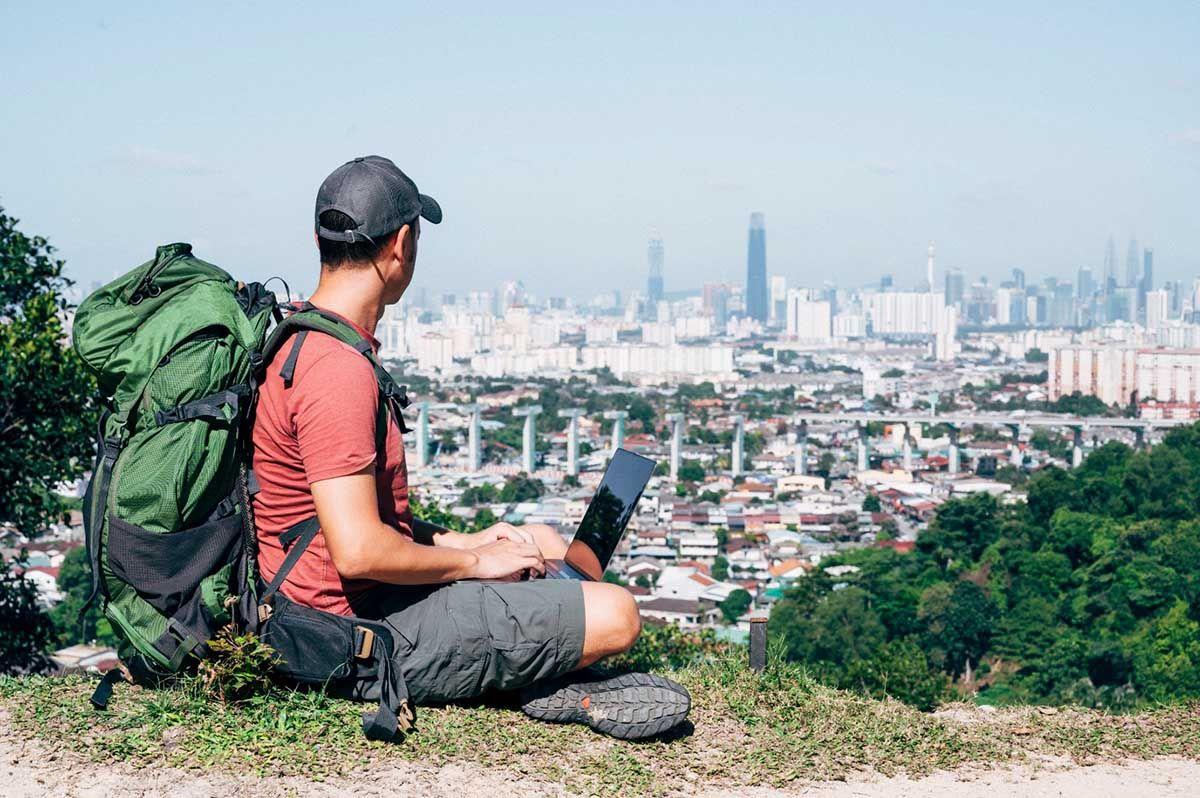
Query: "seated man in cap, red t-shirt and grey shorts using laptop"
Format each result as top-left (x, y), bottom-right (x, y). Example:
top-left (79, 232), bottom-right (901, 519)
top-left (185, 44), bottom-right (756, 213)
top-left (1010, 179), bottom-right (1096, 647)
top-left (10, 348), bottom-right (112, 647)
top-left (253, 156), bottom-right (689, 738)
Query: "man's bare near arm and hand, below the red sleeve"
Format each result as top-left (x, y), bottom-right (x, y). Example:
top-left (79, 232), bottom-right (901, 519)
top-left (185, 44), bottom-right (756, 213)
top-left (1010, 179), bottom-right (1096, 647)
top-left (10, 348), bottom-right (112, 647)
top-left (311, 466), bottom-right (546, 584)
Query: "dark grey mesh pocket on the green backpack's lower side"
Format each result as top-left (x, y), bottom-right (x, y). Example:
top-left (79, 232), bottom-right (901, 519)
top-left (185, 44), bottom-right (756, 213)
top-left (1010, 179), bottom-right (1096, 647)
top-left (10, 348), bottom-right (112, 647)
top-left (107, 515), bottom-right (242, 618)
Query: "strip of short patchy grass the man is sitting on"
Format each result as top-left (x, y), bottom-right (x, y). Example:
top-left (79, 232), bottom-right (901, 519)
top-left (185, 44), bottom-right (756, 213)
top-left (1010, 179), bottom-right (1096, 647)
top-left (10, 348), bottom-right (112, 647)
top-left (0, 660), bottom-right (1200, 796)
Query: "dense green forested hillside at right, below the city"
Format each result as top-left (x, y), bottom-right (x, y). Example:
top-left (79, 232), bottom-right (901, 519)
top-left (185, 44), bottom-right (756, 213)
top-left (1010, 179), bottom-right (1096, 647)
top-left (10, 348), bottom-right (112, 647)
top-left (770, 425), bottom-right (1200, 709)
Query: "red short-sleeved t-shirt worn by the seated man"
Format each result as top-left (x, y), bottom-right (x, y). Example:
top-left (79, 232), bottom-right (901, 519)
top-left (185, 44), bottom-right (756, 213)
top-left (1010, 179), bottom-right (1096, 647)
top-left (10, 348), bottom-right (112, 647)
top-left (253, 307), bottom-right (413, 616)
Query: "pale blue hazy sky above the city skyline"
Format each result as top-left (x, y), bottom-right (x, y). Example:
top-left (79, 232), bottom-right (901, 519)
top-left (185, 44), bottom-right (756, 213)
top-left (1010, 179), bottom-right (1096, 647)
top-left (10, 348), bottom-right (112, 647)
top-left (0, 0), bottom-right (1200, 299)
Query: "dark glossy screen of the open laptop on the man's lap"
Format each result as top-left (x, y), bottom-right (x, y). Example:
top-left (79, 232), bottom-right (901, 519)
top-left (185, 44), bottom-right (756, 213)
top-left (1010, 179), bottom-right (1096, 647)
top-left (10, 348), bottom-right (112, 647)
top-left (565, 449), bottom-right (654, 582)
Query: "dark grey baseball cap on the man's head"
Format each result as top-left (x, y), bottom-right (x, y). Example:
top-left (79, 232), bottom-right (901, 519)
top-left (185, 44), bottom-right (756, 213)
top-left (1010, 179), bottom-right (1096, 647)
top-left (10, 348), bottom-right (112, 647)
top-left (314, 155), bottom-right (442, 244)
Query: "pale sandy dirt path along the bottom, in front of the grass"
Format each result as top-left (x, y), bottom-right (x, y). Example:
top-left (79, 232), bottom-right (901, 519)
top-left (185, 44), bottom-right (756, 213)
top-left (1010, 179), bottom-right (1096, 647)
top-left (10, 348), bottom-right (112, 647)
top-left (0, 724), bottom-right (1200, 798)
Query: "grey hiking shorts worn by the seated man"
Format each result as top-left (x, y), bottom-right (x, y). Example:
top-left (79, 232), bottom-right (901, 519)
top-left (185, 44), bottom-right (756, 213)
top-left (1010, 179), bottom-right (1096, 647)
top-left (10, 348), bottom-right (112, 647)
top-left (355, 580), bottom-right (583, 704)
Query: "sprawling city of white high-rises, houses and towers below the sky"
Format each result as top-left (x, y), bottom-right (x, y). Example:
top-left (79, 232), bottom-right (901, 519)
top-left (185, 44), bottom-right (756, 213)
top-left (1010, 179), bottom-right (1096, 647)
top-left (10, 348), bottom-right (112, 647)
top-left (6, 214), bottom-right (1200, 665)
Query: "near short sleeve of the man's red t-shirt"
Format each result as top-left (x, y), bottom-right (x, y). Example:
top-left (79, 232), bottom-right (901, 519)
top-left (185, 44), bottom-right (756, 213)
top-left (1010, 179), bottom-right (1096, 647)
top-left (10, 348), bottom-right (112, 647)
top-left (292, 349), bottom-right (379, 485)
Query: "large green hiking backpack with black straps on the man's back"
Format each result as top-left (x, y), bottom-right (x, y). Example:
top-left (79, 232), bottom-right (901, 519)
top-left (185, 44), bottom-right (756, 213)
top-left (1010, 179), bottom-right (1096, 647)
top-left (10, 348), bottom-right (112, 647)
top-left (73, 244), bottom-right (412, 738)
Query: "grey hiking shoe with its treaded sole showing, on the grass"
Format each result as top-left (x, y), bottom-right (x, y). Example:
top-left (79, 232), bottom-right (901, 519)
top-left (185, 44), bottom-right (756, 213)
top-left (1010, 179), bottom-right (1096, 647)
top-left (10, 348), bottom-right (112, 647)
top-left (521, 673), bottom-right (691, 740)
